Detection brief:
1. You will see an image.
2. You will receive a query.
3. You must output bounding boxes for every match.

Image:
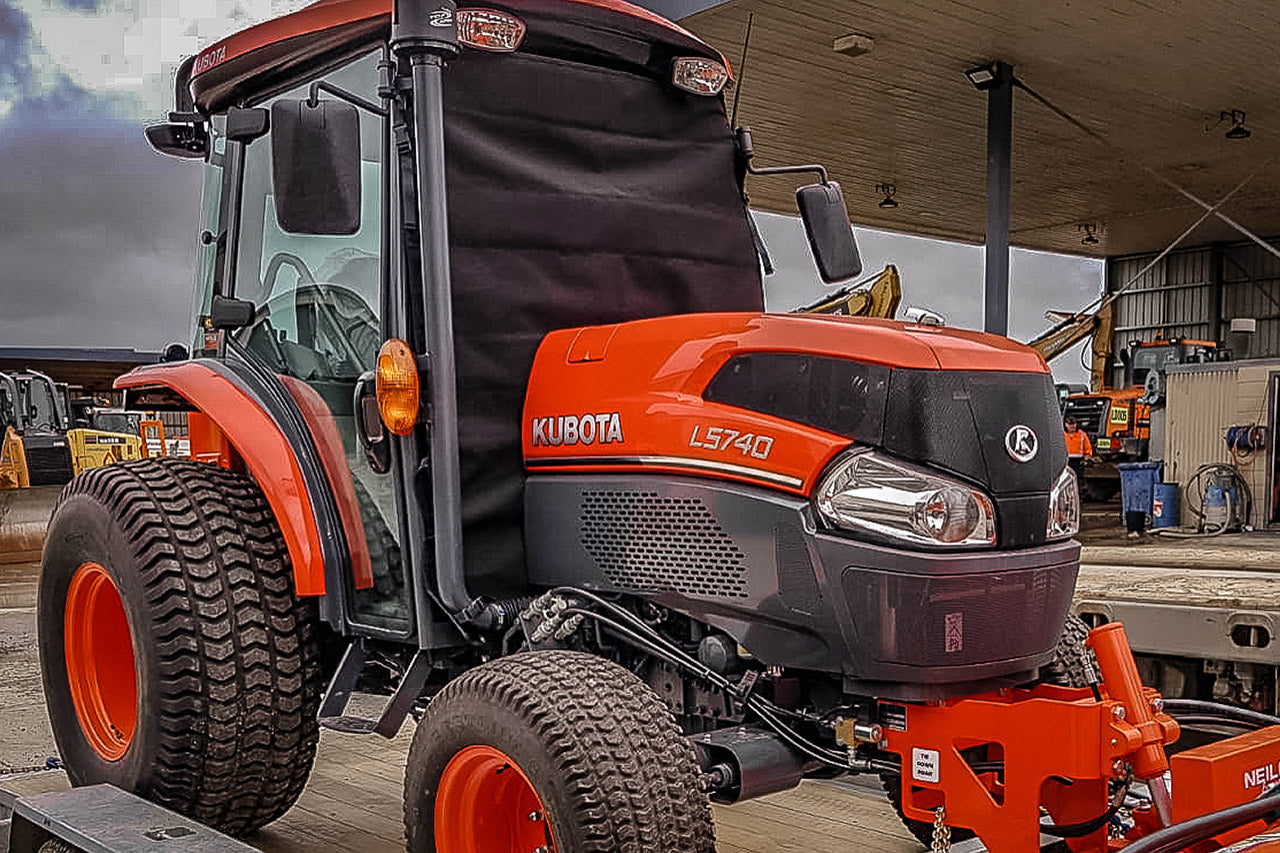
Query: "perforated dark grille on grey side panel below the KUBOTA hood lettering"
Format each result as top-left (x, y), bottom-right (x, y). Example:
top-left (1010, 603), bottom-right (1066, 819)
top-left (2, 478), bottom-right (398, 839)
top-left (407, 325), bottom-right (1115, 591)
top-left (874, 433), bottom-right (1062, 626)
top-left (580, 491), bottom-right (746, 598)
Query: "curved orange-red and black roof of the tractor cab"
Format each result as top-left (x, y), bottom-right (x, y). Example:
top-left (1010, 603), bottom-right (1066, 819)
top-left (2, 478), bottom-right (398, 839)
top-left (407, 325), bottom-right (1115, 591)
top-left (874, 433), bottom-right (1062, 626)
top-left (177, 0), bottom-right (728, 115)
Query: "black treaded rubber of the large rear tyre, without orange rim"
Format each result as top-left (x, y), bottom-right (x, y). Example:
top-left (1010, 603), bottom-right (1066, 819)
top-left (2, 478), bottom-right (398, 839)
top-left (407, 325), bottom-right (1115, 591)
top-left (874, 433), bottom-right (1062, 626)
top-left (40, 459), bottom-right (323, 835)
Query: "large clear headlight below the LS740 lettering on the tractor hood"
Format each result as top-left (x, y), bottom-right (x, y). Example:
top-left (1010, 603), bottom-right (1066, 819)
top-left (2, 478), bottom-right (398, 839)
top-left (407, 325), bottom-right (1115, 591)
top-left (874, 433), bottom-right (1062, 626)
top-left (814, 451), bottom-right (996, 548)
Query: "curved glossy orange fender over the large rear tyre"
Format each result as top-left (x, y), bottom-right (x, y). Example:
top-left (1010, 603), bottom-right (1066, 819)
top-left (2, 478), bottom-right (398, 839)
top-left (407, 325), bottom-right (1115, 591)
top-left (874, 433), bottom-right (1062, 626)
top-left (115, 361), bottom-right (325, 596)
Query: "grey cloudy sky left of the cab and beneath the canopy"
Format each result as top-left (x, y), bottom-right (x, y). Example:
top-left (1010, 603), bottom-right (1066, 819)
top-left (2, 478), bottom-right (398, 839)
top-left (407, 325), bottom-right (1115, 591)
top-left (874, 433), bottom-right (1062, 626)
top-left (0, 0), bottom-right (1101, 382)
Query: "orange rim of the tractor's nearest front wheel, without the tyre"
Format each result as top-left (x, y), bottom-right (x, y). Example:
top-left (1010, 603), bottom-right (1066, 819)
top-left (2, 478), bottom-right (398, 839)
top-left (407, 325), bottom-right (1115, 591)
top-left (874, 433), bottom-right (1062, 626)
top-left (435, 744), bottom-right (556, 853)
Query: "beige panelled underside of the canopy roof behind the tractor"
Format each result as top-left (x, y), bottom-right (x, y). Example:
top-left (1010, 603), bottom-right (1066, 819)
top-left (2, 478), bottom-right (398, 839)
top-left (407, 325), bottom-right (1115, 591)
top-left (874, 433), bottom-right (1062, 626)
top-left (682, 0), bottom-right (1280, 256)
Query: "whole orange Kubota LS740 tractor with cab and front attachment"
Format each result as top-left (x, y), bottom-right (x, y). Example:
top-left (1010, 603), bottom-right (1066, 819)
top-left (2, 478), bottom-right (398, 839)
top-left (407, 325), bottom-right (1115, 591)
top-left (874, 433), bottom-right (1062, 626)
top-left (32, 0), bottom-right (1280, 853)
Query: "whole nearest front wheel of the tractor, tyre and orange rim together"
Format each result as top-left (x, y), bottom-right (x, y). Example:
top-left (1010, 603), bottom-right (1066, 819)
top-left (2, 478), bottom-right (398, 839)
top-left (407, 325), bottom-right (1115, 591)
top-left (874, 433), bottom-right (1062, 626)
top-left (404, 651), bottom-right (716, 853)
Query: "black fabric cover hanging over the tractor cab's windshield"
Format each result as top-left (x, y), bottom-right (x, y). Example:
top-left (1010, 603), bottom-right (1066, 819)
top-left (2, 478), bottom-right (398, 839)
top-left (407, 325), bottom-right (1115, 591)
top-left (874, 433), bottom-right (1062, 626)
top-left (445, 51), bottom-right (764, 596)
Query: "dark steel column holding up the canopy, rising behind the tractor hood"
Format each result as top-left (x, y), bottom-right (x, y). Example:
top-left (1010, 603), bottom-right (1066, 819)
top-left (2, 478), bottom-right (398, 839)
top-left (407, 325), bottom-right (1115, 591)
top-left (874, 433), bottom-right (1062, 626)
top-left (983, 63), bottom-right (1014, 336)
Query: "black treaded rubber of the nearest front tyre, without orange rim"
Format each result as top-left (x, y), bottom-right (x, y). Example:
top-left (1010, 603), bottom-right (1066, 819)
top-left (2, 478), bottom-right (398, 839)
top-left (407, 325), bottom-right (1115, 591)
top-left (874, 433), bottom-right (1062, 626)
top-left (404, 651), bottom-right (716, 853)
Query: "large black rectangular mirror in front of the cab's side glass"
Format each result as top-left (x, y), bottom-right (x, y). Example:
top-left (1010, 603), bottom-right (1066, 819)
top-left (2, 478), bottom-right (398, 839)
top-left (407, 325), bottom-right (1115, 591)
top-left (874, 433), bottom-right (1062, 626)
top-left (271, 100), bottom-right (361, 234)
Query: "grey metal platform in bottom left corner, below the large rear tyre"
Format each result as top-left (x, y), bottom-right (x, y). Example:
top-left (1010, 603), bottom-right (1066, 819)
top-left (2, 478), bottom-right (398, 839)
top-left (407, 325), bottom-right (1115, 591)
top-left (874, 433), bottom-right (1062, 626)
top-left (8, 785), bottom-right (253, 853)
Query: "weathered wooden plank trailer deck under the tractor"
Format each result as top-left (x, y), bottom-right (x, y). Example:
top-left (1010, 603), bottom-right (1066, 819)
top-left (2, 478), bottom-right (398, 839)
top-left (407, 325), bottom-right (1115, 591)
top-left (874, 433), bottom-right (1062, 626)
top-left (0, 725), bottom-right (922, 853)
